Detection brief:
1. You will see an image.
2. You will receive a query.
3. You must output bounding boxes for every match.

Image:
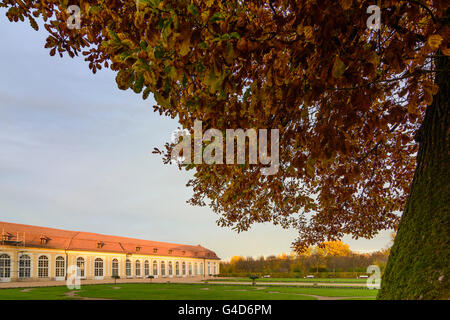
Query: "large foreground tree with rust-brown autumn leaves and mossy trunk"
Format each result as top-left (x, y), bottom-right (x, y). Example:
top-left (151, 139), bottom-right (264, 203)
top-left (0, 0), bottom-right (450, 299)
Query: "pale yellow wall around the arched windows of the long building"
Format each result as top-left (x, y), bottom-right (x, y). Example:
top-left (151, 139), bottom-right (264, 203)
top-left (0, 246), bottom-right (219, 281)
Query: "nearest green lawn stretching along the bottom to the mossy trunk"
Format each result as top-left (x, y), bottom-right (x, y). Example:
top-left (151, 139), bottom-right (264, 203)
top-left (0, 283), bottom-right (377, 300)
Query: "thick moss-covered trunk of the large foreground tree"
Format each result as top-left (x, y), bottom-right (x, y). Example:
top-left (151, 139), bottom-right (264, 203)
top-left (378, 52), bottom-right (450, 299)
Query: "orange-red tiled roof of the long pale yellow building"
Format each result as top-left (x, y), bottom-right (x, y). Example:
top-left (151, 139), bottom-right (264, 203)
top-left (0, 221), bottom-right (219, 259)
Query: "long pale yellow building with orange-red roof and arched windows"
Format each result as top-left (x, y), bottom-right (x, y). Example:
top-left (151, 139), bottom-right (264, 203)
top-left (0, 222), bottom-right (220, 282)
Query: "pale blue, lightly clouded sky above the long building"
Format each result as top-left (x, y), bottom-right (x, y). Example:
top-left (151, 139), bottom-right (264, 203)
top-left (0, 14), bottom-right (390, 259)
